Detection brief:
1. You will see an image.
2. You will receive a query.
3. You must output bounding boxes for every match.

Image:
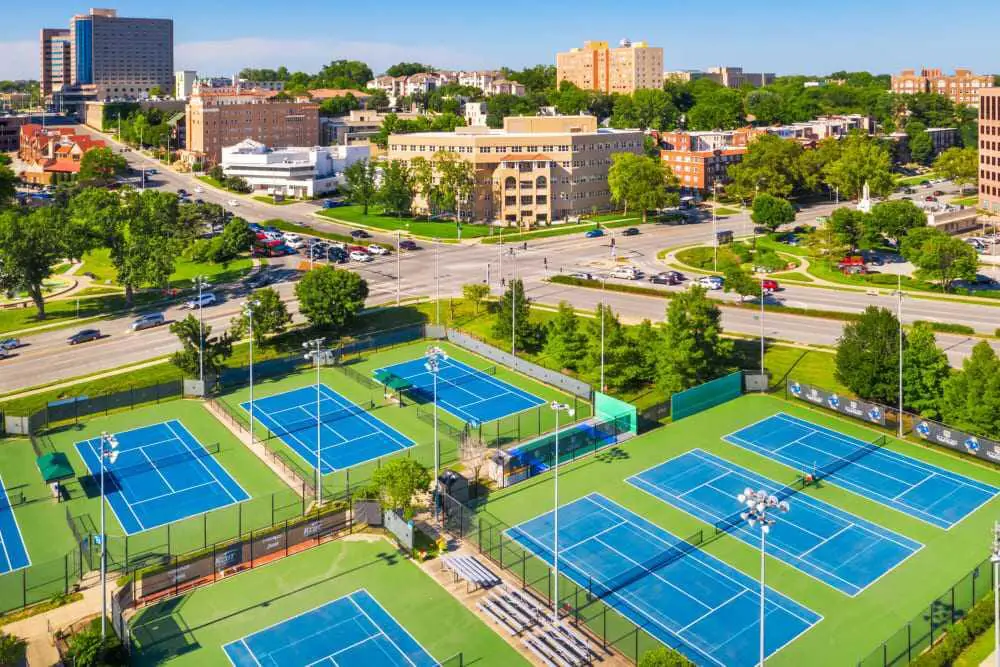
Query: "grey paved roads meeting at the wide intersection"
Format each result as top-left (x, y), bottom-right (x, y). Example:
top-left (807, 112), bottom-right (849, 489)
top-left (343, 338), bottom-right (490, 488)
top-left (0, 130), bottom-right (1000, 392)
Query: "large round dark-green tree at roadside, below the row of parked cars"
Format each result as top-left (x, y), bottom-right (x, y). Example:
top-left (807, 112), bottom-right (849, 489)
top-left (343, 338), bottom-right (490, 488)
top-left (295, 266), bottom-right (368, 335)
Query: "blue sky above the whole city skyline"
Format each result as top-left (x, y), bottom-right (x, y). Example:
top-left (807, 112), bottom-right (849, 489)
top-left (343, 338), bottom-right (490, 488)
top-left (0, 0), bottom-right (1000, 79)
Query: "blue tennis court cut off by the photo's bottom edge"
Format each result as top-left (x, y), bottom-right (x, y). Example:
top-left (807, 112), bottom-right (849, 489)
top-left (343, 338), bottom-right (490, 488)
top-left (223, 589), bottom-right (438, 667)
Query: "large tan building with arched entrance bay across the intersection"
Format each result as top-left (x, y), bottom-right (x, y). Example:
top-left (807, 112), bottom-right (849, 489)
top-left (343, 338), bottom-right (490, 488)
top-left (387, 116), bottom-right (643, 227)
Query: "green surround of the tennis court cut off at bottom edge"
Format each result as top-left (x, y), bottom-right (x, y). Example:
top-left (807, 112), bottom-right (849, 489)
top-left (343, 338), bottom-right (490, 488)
top-left (131, 536), bottom-right (530, 667)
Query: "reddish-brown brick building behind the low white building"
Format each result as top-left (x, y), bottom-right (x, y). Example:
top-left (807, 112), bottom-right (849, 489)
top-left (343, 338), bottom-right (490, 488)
top-left (185, 87), bottom-right (319, 166)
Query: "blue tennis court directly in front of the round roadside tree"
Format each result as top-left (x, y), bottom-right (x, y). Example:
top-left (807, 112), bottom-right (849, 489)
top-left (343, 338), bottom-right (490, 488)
top-left (242, 384), bottom-right (414, 475)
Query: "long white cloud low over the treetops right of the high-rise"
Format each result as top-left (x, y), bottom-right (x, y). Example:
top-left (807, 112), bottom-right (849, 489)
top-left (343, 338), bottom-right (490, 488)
top-left (174, 37), bottom-right (487, 75)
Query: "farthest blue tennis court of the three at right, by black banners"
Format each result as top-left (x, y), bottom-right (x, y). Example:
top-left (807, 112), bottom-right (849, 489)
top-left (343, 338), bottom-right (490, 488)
top-left (724, 412), bottom-right (1000, 530)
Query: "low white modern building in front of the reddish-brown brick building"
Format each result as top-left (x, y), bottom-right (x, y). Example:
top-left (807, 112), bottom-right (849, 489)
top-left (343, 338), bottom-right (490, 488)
top-left (222, 139), bottom-right (370, 198)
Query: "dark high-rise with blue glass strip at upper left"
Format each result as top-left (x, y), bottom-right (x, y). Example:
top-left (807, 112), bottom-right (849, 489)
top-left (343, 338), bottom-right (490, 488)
top-left (42, 9), bottom-right (174, 99)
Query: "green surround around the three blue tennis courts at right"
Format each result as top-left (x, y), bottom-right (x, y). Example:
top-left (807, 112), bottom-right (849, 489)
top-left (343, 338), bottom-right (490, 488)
top-left (474, 394), bottom-right (1000, 667)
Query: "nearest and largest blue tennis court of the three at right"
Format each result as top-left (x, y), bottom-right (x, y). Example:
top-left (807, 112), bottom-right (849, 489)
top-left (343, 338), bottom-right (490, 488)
top-left (508, 493), bottom-right (821, 667)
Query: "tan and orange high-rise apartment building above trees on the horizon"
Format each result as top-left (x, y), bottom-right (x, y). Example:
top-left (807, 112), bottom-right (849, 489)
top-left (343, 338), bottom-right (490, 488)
top-left (556, 39), bottom-right (663, 95)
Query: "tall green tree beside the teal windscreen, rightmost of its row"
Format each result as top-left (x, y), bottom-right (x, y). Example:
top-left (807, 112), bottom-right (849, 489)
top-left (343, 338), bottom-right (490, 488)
top-left (657, 286), bottom-right (733, 395)
